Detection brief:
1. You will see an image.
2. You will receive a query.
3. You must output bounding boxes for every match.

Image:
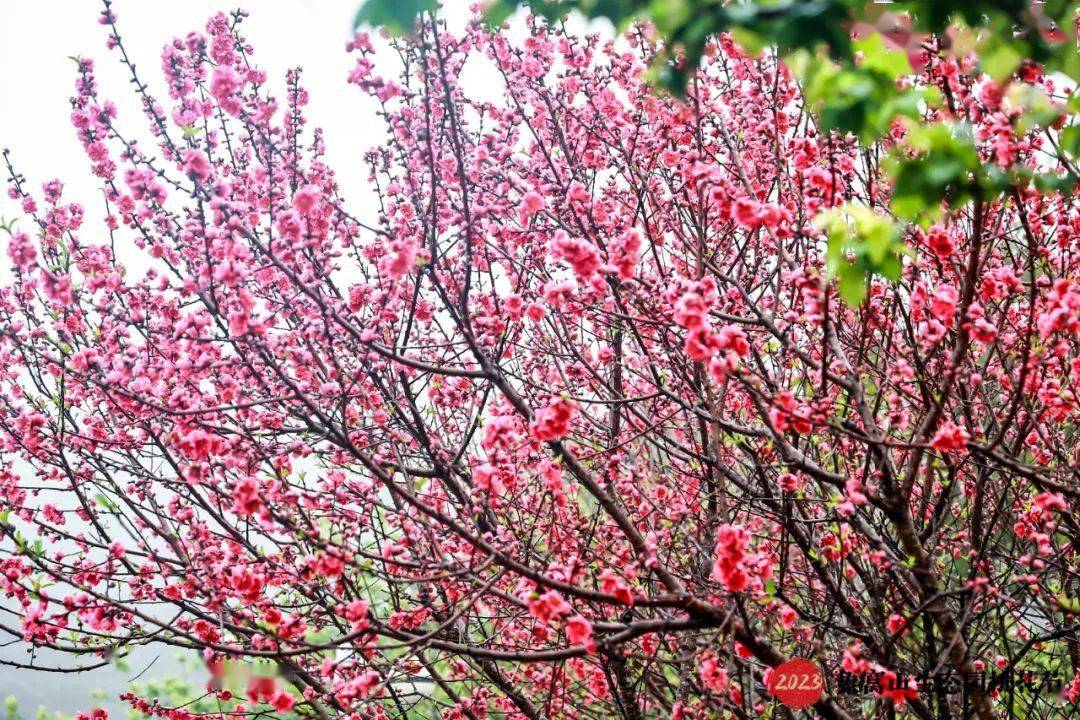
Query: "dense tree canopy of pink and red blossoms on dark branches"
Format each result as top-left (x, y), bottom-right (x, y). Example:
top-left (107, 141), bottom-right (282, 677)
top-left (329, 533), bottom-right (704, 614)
top-left (0, 5), bottom-right (1080, 720)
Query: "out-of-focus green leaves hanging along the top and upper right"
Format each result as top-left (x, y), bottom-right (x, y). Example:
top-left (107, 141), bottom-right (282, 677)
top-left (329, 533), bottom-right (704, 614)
top-left (355, 0), bottom-right (1080, 305)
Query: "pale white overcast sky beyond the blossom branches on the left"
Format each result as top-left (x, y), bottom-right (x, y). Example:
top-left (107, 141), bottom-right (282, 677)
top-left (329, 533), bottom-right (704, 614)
top-left (0, 0), bottom-right (468, 719)
